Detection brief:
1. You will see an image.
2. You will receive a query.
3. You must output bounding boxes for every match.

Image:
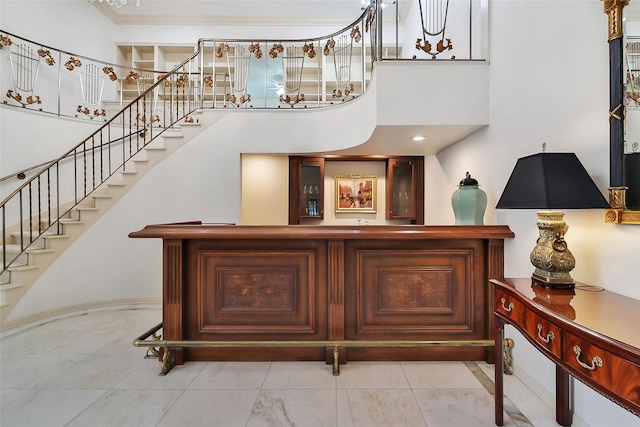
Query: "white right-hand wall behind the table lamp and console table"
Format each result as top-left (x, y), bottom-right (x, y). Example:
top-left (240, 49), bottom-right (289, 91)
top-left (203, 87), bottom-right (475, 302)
top-left (438, 0), bottom-right (640, 427)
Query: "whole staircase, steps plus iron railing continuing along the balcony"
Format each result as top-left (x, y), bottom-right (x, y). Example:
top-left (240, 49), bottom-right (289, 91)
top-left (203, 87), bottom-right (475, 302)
top-left (0, 6), bottom-right (381, 331)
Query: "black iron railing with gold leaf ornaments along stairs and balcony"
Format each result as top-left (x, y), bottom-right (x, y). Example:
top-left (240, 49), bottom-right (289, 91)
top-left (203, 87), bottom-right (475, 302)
top-left (0, 6), bottom-right (375, 288)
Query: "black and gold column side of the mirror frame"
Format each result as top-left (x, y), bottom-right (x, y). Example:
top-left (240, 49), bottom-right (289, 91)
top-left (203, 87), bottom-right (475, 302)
top-left (603, 0), bottom-right (640, 224)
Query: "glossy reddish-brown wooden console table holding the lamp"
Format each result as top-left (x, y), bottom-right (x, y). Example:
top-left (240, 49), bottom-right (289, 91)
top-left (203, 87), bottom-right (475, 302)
top-left (490, 278), bottom-right (640, 426)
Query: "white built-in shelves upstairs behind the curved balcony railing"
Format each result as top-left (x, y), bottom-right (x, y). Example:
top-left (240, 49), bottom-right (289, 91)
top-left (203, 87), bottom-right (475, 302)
top-left (116, 42), bottom-right (397, 108)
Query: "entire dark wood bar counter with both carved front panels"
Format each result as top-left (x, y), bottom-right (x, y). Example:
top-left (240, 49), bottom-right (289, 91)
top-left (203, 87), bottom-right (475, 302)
top-left (130, 223), bottom-right (513, 363)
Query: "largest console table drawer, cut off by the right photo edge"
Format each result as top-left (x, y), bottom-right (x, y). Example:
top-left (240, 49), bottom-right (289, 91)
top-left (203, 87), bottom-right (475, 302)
top-left (565, 334), bottom-right (640, 408)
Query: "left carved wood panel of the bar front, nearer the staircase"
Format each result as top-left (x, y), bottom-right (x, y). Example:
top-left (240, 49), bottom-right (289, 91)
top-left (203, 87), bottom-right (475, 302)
top-left (184, 239), bottom-right (328, 360)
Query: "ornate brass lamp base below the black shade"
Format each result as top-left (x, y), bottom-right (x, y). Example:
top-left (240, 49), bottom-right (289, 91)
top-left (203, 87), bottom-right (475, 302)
top-left (529, 211), bottom-right (576, 289)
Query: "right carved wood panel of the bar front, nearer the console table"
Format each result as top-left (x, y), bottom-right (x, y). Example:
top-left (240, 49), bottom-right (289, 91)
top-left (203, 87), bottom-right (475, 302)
top-left (345, 239), bottom-right (490, 360)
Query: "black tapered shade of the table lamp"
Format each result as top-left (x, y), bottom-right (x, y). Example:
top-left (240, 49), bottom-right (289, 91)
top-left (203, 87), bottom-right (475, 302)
top-left (496, 153), bottom-right (609, 209)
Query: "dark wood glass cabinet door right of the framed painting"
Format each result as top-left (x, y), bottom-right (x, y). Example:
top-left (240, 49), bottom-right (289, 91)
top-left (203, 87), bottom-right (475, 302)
top-left (387, 157), bottom-right (424, 224)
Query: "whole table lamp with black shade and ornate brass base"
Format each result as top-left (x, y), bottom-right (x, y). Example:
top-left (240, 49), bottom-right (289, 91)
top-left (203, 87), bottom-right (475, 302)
top-left (496, 151), bottom-right (609, 289)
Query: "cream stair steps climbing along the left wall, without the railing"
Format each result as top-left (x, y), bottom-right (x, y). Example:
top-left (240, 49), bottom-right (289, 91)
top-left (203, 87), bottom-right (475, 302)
top-left (0, 110), bottom-right (225, 330)
